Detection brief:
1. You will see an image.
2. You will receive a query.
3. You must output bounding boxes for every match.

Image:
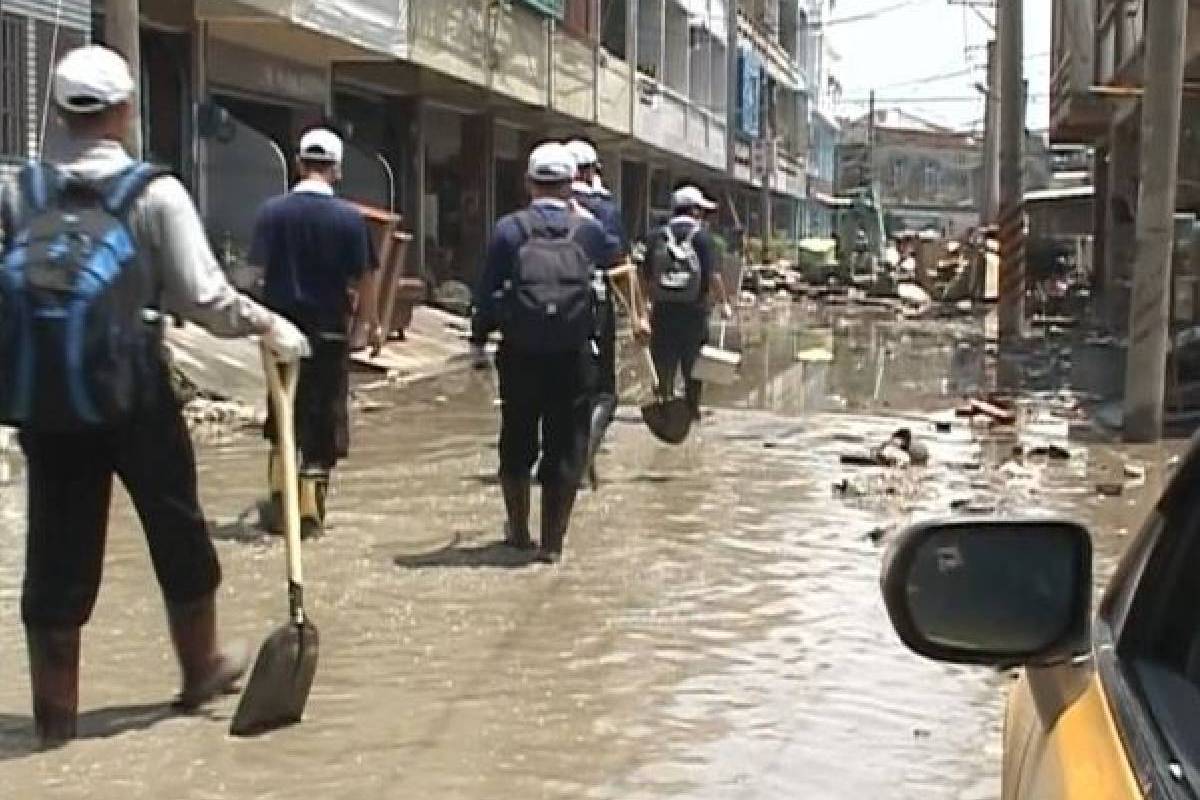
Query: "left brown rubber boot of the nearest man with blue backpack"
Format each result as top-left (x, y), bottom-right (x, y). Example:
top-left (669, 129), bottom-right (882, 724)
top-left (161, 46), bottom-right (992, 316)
top-left (25, 627), bottom-right (79, 750)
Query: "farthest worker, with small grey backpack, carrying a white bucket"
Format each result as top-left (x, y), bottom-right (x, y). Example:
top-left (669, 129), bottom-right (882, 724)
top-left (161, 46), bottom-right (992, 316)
top-left (642, 186), bottom-right (733, 420)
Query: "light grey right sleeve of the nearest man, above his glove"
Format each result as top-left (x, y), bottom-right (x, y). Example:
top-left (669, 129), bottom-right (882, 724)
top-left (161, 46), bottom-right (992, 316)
top-left (142, 178), bottom-right (274, 338)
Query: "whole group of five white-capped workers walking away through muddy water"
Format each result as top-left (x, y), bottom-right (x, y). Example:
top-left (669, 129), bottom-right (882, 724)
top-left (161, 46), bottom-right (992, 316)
top-left (0, 46), bottom-right (732, 746)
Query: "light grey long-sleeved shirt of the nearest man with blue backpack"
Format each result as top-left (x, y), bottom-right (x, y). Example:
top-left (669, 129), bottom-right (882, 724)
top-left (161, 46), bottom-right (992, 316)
top-left (0, 139), bottom-right (274, 338)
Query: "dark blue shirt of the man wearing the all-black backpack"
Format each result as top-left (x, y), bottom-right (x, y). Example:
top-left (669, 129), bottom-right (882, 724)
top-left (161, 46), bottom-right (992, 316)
top-left (470, 200), bottom-right (617, 344)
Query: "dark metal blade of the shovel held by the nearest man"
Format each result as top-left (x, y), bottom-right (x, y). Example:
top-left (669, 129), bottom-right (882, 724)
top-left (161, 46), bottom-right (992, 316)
top-left (229, 622), bottom-right (320, 736)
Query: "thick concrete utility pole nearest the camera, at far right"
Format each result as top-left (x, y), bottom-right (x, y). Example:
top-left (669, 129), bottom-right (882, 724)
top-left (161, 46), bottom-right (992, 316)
top-left (1124, 0), bottom-right (1188, 441)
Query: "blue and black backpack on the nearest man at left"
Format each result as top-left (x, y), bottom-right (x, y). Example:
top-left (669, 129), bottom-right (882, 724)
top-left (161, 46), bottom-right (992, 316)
top-left (0, 163), bottom-right (164, 433)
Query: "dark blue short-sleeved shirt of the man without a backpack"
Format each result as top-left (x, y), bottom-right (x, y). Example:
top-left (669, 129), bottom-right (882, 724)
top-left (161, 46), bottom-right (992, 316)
top-left (250, 185), bottom-right (376, 330)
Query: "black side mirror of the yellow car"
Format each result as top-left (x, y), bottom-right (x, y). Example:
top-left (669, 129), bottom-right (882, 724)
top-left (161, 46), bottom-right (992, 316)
top-left (882, 521), bottom-right (1092, 667)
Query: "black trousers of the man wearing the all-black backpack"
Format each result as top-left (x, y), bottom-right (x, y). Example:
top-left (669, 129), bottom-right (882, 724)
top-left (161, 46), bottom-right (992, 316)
top-left (496, 347), bottom-right (595, 486)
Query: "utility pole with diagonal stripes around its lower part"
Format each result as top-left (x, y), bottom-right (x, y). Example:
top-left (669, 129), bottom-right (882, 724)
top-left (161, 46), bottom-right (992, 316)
top-left (996, 0), bottom-right (1025, 343)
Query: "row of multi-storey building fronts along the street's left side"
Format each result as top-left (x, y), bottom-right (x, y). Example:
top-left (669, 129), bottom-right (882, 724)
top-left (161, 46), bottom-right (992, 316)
top-left (0, 0), bottom-right (835, 285)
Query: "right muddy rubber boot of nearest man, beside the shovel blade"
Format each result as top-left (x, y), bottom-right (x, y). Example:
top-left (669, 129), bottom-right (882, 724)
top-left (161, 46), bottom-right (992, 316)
top-left (167, 594), bottom-right (250, 711)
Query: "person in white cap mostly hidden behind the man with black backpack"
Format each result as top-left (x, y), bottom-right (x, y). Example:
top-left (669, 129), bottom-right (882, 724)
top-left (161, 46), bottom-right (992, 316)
top-left (566, 139), bottom-right (637, 489)
